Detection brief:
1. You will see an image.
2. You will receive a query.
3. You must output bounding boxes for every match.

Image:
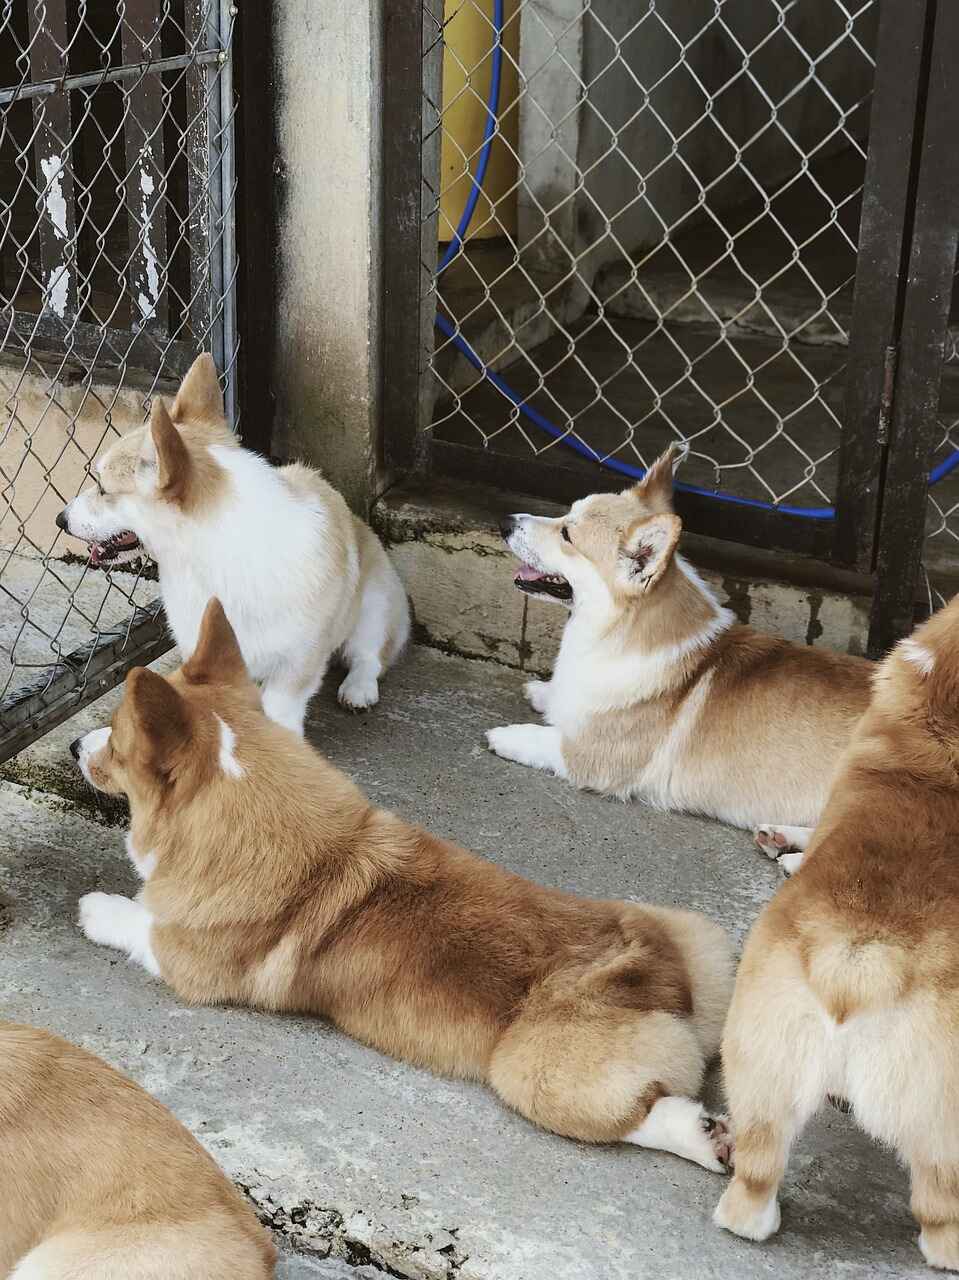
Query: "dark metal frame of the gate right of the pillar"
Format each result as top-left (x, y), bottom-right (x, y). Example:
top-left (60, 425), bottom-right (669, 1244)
top-left (383, 0), bottom-right (959, 655)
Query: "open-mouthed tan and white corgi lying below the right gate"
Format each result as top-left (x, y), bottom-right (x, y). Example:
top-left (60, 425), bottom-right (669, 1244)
top-left (487, 449), bottom-right (872, 858)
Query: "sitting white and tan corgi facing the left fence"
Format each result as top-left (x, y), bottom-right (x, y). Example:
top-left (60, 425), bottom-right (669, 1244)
top-left (56, 355), bottom-right (410, 733)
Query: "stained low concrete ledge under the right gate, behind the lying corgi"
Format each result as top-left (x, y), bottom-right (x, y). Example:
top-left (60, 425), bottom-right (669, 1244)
top-left (373, 481), bottom-right (871, 673)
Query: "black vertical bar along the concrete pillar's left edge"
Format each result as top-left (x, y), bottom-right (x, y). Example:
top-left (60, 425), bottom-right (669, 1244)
top-left (233, 4), bottom-right (277, 457)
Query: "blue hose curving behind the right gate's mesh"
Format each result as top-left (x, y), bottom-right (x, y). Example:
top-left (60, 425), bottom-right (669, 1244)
top-left (435, 0), bottom-right (959, 520)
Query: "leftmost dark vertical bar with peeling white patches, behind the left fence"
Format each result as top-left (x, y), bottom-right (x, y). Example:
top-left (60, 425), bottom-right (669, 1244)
top-left (27, 0), bottom-right (77, 319)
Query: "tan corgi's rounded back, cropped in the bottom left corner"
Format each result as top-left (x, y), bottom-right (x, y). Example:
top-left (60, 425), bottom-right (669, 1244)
top-left (0, 1021), bottom-right (277, 1280)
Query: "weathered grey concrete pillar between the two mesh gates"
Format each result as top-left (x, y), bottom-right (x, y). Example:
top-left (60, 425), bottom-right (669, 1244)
top-left (264, 0), bottom-right (383, 513)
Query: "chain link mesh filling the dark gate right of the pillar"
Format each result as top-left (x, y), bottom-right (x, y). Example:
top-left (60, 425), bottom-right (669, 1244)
top-left (423, 0), bottom-right (877, 507)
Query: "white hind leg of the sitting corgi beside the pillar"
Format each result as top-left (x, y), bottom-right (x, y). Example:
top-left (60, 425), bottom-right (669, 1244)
top-left (337, 526), bottom-right (410, 710)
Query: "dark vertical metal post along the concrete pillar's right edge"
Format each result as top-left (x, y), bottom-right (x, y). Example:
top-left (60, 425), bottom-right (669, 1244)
top-left (382, 0), bottom-right (424, 481)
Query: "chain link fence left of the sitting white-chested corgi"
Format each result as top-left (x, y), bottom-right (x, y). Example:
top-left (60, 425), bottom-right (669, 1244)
top-left (0, 0), bottom-right (237, 759)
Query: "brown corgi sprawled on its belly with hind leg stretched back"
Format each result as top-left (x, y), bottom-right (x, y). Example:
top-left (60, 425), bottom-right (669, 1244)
top-left (73, 600), bottom-right (732, 1171)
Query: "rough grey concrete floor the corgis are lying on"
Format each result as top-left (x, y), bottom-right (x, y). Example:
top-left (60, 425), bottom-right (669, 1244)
top-left (0, 649), bottom-right (927, 1280)
